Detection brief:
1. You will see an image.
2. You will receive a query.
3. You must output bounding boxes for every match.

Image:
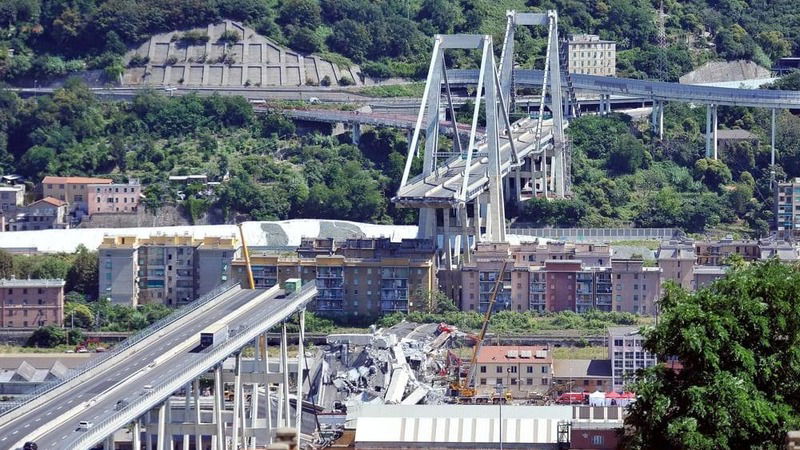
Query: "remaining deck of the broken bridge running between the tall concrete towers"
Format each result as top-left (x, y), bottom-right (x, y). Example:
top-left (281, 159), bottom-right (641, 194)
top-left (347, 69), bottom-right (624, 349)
top-left (392, 118), bottom-right (552, 208)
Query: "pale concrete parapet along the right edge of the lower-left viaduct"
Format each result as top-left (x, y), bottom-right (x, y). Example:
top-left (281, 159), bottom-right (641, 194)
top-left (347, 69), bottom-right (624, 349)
top-left (71, 282), bottom-right (317, 450)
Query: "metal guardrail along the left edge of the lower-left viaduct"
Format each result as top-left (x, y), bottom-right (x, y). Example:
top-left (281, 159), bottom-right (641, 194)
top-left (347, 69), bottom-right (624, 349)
top-left (0, 281), bottom-right (239, 416)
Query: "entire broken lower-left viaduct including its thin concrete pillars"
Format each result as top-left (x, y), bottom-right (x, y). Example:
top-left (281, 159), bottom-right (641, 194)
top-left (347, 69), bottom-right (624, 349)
top-left (6, 283), bottom-right (316, 450)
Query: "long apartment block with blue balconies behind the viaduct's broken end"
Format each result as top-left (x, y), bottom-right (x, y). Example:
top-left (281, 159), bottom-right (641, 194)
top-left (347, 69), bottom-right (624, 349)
top-left (232, 238), bottom-right (437, 317)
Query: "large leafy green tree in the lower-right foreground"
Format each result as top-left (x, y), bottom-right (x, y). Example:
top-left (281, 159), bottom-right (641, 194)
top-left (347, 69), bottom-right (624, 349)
top-left (625, 260), bottom-right (800, 450)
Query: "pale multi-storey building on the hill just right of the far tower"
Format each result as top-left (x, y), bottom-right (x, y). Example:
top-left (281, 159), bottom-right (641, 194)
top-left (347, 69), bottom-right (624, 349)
top-left (562, 34), bottom-right (617, 77)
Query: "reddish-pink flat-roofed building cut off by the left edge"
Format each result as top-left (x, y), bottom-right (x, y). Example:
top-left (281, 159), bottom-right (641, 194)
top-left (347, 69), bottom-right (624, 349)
top-left (0, 279), bottom-right (64, 328)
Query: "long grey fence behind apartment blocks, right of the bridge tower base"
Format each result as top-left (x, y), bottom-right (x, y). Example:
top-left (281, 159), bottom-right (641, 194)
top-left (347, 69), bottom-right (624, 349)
top-left (506, 226), bottom-right (680, 242)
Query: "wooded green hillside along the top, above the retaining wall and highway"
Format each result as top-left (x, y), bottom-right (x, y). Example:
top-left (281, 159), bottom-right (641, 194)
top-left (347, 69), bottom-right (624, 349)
top-left (0, 0), bottom-right (800, 81)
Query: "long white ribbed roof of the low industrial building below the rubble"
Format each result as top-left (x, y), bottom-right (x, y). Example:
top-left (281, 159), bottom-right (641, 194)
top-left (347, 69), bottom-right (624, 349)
top-left (348, 405), bottom-right (572, 445)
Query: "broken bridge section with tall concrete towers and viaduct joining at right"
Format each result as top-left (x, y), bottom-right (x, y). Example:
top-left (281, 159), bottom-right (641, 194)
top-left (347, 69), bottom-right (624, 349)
top-left (392, 11), bottom-right (800, 267)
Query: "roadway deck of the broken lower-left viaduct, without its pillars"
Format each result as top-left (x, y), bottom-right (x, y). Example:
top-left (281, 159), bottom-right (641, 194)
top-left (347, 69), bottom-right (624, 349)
top-left (7, 286), bottom-right (316, 449)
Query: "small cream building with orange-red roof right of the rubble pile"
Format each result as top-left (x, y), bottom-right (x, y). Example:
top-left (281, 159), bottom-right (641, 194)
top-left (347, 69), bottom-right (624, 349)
top-left (475, 345), bottom-right (553, 398)
